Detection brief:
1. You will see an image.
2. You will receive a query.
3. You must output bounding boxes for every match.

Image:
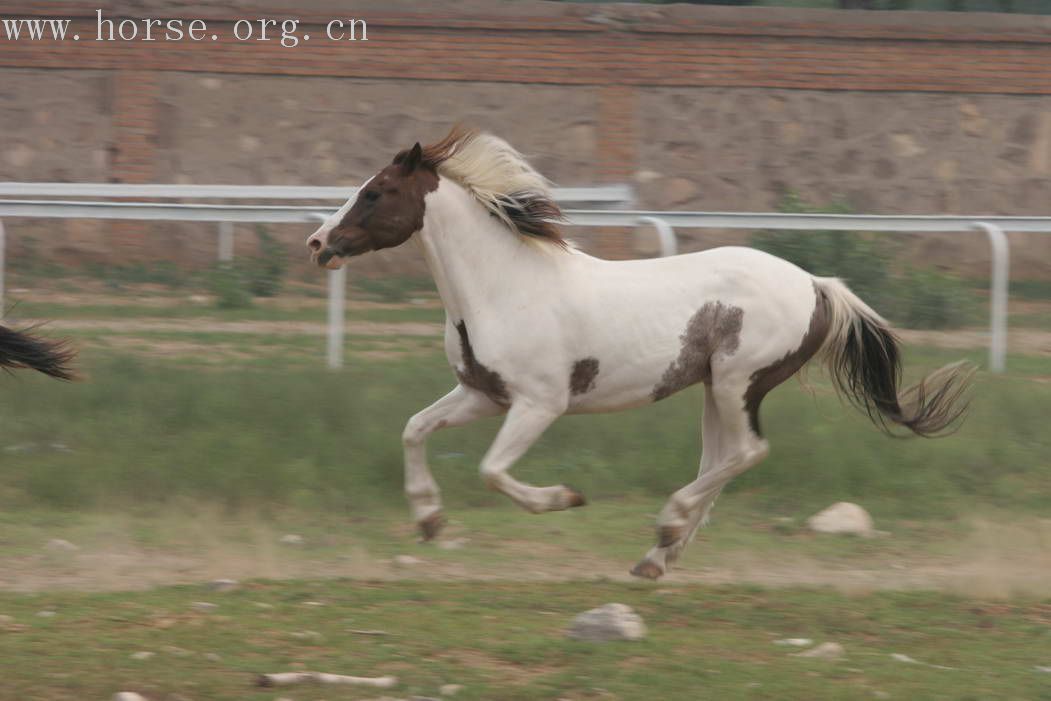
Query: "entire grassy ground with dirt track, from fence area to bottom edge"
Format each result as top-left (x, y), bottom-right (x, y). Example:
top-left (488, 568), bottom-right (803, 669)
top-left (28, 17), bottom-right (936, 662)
top-left (0, 279), bottom-right (1051, 701)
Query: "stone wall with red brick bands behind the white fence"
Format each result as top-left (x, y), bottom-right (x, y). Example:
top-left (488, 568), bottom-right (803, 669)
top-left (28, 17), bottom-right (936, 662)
top-left (0, 0), bottom-right (1051, 271)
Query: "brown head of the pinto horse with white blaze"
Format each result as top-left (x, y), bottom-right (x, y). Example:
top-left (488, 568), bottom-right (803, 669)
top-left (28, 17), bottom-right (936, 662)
top-left (307, 143), bottom-right (438, 270)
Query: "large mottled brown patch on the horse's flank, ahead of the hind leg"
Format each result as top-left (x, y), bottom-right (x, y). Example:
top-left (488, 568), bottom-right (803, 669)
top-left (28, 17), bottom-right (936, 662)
top-left (653, 302), bottom-right (744, 401)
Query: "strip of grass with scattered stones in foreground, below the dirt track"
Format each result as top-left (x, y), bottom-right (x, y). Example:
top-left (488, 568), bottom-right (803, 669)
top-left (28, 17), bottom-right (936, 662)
top-left (0, 579), bottom-right (1051, 701)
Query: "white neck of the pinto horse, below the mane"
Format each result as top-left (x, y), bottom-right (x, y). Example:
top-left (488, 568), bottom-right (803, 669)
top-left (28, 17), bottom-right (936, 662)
top-left (418, 179), bottom-right (557, 322)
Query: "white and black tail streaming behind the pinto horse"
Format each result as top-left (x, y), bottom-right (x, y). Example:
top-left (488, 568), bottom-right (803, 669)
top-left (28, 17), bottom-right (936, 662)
top-left (815, 277), bottom-right (975, 437)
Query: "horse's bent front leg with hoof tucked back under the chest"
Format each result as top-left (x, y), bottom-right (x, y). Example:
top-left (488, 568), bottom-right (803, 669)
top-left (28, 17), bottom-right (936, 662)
top-left (481, 400), bottom-right (585, 514)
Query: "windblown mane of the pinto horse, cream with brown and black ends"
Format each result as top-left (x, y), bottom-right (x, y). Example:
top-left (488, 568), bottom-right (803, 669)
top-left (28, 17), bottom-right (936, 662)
top-left (424, 126), bottom-right (566, 247)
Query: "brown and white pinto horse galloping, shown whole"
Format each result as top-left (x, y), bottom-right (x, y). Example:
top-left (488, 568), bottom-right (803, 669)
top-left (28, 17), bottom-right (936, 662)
top-left (307, 127), bottom-right (974, 579)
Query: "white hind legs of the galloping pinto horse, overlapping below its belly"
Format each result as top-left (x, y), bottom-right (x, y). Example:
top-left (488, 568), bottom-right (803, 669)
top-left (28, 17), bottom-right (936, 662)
top-left (632, 377), bottom-right (769, 579)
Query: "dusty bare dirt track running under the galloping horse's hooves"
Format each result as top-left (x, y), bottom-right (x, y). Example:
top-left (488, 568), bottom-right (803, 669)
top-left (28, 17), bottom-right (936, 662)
top-left (0, 510), bottom-right (1051, 598)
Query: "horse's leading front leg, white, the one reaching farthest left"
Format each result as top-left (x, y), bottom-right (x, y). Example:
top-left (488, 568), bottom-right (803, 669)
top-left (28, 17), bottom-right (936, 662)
top-left (401, 385), bottom-right (503, 540)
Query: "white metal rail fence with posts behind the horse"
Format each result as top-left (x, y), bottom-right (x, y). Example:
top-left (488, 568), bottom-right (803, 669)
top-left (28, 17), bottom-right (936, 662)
top-left (0, 183), bottom-right (1051, 372)
